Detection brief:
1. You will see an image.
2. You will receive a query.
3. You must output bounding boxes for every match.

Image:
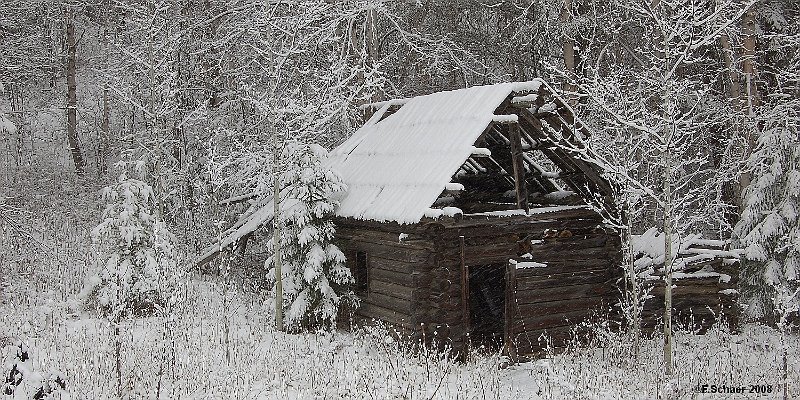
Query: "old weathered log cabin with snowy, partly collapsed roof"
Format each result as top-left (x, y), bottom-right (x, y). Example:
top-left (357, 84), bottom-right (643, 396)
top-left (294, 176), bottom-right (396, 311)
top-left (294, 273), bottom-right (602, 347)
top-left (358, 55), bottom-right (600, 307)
top-left (197, 80), bottom-right (624, 354)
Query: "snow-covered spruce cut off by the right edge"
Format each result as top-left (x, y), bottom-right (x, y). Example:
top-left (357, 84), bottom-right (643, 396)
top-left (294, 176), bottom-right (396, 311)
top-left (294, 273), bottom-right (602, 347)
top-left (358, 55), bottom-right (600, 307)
top-left (734, 103), bottom-right (800, 326)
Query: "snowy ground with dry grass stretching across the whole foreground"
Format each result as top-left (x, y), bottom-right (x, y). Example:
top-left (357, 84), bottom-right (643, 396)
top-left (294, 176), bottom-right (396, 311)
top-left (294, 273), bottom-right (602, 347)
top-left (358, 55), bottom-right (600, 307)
top-left (0, 167), bottom-right (800, 399)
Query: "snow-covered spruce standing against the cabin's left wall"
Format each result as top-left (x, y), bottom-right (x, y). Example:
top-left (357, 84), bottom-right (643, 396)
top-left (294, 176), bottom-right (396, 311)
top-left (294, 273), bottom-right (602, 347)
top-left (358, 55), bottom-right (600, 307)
top-left (265, 142), bottom-right (358, 331)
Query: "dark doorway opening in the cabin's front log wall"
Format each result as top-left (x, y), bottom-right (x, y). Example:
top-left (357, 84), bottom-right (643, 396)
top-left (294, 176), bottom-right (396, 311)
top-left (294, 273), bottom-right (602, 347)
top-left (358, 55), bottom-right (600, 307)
top-left (468, 264), bottom-right (506, 350)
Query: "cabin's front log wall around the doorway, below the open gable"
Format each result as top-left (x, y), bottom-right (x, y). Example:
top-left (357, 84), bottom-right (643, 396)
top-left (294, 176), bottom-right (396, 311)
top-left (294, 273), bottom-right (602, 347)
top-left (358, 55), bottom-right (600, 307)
top-left (428, 209), bottom-right (621, 353)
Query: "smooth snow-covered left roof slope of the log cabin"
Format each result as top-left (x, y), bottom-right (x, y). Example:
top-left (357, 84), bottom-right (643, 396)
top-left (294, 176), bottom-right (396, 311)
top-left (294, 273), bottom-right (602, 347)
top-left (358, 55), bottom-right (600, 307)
top-left (329, 80), bottom-right (542, 224)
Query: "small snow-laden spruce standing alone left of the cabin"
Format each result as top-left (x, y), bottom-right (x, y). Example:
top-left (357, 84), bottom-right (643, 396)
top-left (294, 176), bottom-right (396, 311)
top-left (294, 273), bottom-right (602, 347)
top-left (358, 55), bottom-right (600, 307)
top-left (79, 164), bottom-right (177, 321)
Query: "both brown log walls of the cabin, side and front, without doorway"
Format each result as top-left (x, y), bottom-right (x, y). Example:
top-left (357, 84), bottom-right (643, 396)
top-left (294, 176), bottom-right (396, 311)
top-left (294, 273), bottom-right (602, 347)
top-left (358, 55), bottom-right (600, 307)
top-left (336, 208), bottom-right (621, 354)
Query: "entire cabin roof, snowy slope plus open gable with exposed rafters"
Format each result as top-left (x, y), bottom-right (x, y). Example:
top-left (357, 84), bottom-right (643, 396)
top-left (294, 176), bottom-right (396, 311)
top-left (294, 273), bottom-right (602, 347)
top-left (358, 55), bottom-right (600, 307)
top-left (330, 79), bottom-right (613, 224)
